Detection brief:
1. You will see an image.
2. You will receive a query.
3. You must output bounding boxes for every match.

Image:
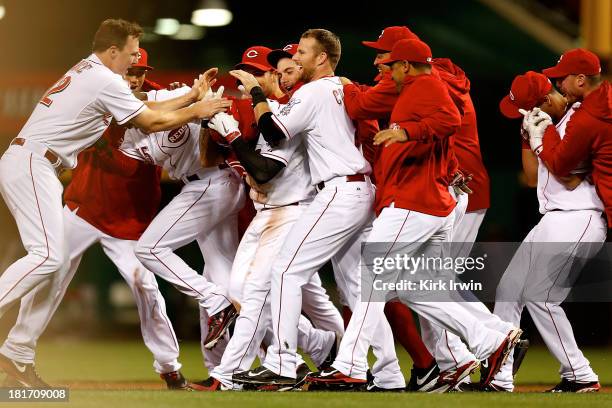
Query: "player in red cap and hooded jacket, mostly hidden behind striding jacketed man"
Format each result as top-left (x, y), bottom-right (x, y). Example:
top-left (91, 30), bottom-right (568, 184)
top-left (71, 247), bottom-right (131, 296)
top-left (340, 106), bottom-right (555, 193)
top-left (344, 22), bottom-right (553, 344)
top-left (343, 26), bottom-right (489, 391)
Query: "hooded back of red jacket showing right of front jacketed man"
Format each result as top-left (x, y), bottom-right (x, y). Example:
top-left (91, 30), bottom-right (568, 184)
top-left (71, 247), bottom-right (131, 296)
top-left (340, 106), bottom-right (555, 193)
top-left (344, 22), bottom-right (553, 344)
top-left (433, 58), bottom-right (491, 212)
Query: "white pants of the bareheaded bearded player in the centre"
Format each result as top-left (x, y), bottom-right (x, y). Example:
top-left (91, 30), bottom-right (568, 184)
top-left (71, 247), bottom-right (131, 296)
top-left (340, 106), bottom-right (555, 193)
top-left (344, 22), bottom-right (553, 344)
top-left (264, 177), bottom-right (405, 386)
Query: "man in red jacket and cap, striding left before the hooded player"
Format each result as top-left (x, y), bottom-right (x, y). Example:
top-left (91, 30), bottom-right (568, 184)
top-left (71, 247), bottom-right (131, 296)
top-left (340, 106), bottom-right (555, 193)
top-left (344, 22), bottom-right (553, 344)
top-left (306, 39), bottom-right (521, 392)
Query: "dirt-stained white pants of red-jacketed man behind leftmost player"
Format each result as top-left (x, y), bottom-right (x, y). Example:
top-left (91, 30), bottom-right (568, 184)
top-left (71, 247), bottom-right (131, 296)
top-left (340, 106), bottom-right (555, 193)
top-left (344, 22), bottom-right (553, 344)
top-left (0, 207), bottom-right (181, 373)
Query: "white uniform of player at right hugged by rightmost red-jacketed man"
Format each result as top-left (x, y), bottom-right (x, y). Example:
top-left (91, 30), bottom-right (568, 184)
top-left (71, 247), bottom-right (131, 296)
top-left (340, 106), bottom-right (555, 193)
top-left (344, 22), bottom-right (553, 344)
top-left (494, 103), bottom-right (606, 390)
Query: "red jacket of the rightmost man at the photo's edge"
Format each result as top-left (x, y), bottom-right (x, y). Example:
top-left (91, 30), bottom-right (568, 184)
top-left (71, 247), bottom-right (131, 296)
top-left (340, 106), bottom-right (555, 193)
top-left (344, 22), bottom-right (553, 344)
top-left (540, 81), bottom-right (612, 227)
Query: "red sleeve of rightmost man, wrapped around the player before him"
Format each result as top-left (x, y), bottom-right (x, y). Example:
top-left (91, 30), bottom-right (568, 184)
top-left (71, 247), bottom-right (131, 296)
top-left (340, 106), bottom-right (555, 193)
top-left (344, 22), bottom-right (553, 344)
top-left (540, 113), bottom-right (595, 176)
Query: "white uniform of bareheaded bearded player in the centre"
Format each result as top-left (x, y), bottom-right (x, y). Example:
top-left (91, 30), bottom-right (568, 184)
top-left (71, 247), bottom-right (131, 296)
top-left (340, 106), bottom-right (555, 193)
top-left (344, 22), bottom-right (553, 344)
top-left (256, 77), bottom-right (405, 387)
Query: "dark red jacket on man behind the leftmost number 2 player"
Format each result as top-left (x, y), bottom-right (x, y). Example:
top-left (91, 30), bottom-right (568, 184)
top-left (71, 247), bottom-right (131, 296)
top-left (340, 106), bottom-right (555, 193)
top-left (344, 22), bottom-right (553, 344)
top-left (64, 82), bottom-right (161, 240)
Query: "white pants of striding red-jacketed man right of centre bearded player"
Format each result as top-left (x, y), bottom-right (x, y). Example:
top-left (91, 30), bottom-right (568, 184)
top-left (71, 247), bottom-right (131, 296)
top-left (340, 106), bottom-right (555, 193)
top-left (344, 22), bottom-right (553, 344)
top-left (333, 207), bottom-right (513, 378)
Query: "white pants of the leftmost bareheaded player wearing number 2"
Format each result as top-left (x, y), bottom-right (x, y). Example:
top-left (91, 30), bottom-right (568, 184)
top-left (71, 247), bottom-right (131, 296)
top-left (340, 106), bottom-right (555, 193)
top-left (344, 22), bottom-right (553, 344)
top-left (0, 145), bottom-right (68, 363)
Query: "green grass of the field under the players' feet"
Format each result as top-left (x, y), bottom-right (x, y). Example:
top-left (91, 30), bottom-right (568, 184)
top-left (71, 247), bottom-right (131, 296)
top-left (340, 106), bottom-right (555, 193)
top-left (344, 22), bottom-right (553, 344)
top-left (21, 341), bottom-right (612, 408)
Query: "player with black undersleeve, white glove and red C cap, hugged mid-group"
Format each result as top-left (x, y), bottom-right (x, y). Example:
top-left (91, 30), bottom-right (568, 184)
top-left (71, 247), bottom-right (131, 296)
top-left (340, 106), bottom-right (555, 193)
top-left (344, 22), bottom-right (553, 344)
top-left (190, 46), bottom-right (343, 391)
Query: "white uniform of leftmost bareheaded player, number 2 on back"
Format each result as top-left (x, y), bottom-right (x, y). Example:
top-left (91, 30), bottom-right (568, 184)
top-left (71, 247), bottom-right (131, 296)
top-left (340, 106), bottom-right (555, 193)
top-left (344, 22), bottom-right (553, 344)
top-left (0, 54), bottom-right (145, 350)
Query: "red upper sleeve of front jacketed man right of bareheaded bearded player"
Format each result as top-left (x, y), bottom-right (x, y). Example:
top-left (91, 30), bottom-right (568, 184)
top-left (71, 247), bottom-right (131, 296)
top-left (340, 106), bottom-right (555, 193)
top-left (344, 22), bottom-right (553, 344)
top-left (397, 81), bottom-right (461, 142)
